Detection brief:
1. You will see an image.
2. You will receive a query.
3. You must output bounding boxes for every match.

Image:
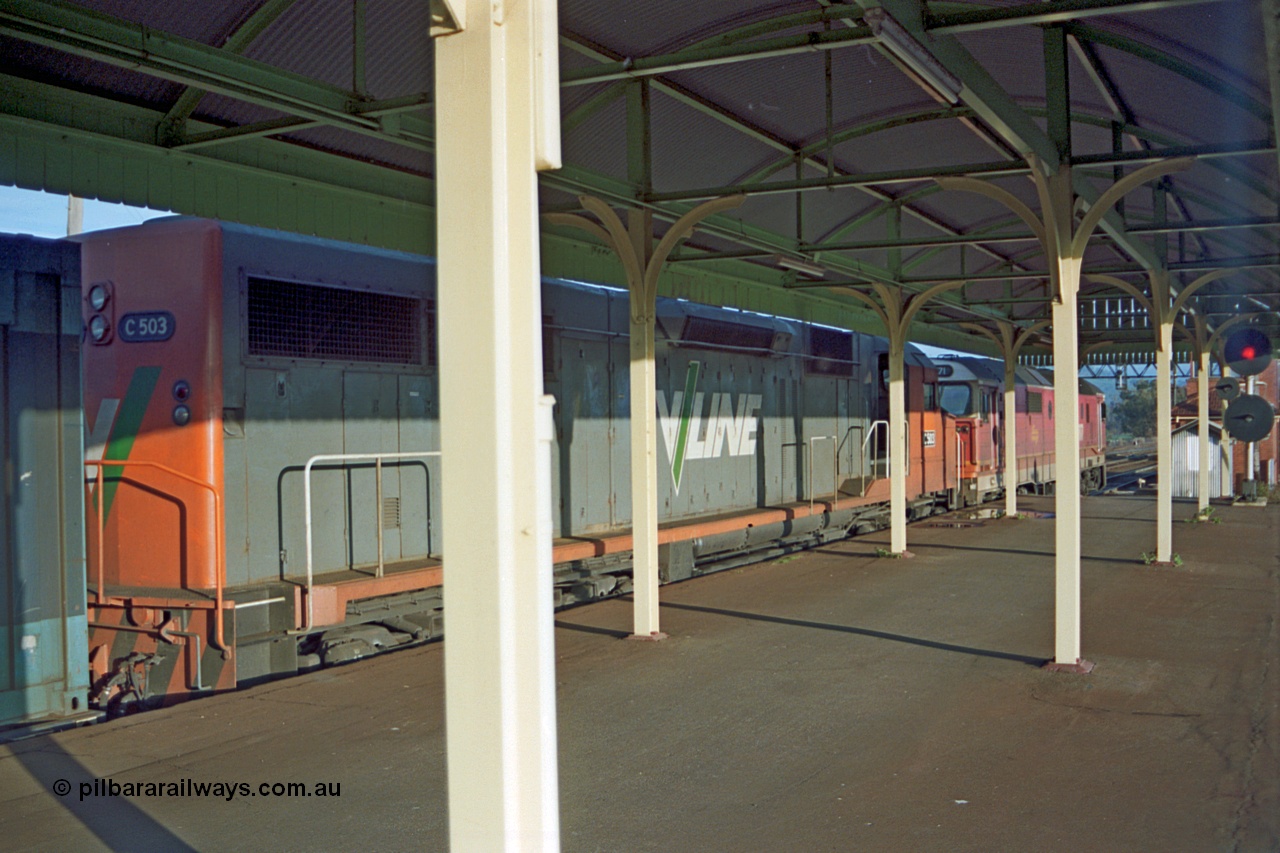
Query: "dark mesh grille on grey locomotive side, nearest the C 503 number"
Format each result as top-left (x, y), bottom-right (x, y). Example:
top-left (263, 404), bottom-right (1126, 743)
top-left (246, 278), bottom-right (422, 364)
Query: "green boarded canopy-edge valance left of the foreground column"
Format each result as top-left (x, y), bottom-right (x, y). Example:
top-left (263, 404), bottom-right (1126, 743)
top-left (0, 77), bottom-right (435, 254)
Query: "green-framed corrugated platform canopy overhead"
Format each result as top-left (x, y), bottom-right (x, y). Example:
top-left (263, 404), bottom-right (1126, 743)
top-left (0, 0), bottom-right (1280, 361)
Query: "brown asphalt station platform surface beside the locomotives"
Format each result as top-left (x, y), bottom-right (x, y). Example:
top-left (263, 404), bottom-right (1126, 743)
top-left (0, 497), bottom-right (1280, 852)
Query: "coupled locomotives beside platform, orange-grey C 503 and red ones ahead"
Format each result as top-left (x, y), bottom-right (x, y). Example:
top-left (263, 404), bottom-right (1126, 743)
top-left (0, 219), bottom-right (1106, 710)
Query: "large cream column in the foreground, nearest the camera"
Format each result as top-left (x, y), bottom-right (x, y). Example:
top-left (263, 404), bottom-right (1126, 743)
top-left (435, 0), bottom-right (559, 850)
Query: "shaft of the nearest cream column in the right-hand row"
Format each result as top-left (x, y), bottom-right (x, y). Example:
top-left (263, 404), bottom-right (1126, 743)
top-left (1053, 257), bottom-right (1080, 666)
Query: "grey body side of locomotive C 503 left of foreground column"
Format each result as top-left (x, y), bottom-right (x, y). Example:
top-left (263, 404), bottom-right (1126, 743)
top-left (221, 224), bottom-right (442, 587)
